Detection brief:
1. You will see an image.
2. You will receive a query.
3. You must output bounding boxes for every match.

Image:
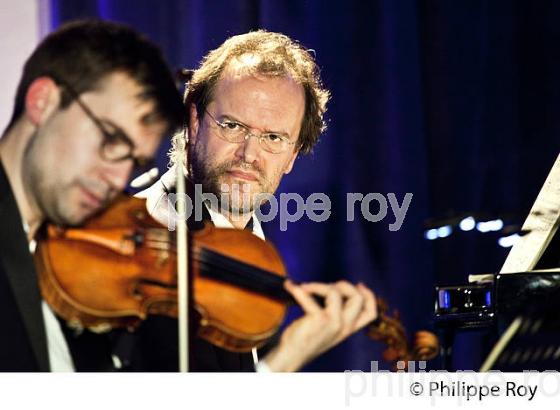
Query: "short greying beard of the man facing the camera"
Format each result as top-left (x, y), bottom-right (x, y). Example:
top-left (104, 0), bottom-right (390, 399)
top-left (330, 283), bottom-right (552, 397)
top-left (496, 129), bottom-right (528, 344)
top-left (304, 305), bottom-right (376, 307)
top-left (189, 150), bottom-right (271, 215)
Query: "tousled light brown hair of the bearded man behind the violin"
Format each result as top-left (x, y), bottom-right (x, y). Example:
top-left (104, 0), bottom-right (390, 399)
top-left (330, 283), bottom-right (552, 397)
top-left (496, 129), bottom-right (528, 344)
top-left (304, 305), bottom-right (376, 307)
top-left (169, 30), bottom-right (330, 166)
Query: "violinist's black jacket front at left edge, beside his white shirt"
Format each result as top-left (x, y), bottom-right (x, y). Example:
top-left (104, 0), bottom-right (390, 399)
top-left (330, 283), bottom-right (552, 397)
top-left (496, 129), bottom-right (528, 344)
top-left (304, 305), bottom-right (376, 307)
top-left (0, 165), bottom-right (50, 371)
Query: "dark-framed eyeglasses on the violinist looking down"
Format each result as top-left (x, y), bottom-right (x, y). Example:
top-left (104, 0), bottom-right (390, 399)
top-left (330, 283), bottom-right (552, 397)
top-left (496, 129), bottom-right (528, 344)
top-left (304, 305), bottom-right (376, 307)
top-left (56, 80), bottom-right (154, 171)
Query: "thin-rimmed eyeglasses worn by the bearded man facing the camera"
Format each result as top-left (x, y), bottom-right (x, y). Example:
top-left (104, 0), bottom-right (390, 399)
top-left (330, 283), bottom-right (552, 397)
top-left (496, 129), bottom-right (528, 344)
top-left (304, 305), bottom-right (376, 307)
top-left (206, 110), bottom-right (295, 154)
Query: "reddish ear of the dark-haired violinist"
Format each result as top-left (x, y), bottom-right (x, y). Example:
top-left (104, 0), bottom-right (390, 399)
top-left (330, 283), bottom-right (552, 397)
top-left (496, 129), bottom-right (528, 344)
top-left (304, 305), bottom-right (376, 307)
top-left (25, 77), bottom-right (60, 126)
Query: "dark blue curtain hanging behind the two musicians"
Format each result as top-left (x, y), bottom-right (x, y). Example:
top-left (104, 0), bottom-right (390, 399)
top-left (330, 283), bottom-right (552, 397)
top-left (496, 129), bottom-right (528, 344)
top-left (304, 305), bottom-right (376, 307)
top-left (44, 0), bottom-right (560, 371)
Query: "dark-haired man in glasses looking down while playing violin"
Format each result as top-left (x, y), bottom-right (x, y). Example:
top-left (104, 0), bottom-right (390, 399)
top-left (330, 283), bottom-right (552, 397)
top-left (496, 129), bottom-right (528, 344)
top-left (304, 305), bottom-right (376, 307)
top-left (0, 21), bottom-right (183, 371)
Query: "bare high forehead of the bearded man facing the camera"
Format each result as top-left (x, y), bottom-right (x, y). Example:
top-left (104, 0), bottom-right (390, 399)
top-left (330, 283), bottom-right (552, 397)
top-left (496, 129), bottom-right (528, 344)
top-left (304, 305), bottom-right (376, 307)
top-left (212, 66), bottom-right (305, 136)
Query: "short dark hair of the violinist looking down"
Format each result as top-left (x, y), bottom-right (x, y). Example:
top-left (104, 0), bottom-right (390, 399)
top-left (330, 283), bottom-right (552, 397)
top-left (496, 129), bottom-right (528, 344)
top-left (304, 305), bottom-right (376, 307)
top-left (7, 19), bottom-right (184, 132)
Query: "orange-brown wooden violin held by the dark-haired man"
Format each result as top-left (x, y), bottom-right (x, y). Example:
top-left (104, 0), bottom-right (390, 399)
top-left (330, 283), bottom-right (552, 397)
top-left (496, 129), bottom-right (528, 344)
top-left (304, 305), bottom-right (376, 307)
top-left (35, 195), bottom-right (438, 361)
